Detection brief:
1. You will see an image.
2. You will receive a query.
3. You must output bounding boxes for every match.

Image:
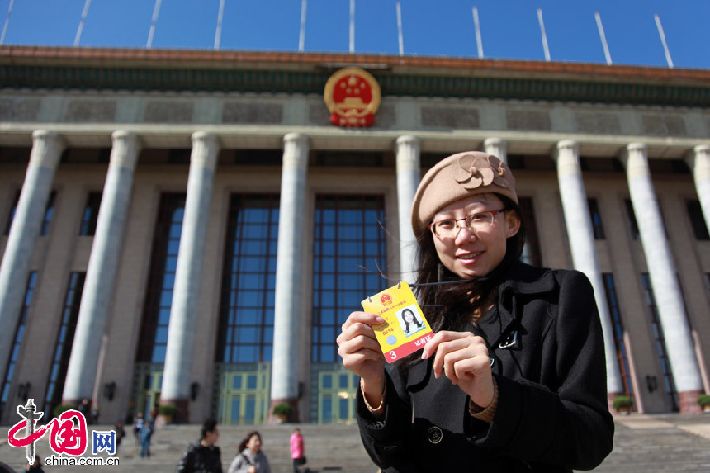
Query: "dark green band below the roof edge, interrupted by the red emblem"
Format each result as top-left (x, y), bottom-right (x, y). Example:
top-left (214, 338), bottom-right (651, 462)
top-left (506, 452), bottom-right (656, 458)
top-left (0, 65), bottom-right (710, 107)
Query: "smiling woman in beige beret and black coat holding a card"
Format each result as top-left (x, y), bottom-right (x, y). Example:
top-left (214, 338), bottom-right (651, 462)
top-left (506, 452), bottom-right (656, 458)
top-left (338, 152), bottom-right (614, 472)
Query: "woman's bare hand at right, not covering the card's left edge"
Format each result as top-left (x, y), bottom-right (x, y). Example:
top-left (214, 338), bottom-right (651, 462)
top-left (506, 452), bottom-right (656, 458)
top-left (422, 330), bottom-right (495, 408)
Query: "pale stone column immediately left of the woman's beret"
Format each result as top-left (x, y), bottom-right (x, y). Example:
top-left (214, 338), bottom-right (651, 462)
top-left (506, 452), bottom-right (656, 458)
top-left (397, 135), bottom-right (419, 284)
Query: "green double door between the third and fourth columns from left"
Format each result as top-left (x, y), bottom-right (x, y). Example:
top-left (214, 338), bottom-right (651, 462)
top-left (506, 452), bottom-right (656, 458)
top-left (218, 363), bottom-right (271, 425)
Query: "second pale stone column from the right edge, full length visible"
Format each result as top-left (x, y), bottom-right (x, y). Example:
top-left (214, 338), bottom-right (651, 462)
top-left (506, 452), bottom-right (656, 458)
top-left (623, 143), bottom-right (702, 412)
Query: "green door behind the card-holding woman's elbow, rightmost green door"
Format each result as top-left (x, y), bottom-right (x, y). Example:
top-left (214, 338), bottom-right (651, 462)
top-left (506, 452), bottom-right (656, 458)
top-left (318, 368), bottom-right (358, 424)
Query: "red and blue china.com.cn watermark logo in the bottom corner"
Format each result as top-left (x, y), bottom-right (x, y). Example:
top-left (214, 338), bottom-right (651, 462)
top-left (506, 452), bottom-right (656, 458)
top-left (7, 399), bottom-right (118, 465)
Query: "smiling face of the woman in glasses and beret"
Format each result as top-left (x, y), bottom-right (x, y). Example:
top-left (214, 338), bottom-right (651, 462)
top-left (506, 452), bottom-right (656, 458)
top-left (432, 194), bottom-right (520, 279)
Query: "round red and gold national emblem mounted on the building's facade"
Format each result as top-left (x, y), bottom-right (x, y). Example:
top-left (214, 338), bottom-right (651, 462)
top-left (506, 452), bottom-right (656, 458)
top-left (323, 67), bottom-right (381, 126)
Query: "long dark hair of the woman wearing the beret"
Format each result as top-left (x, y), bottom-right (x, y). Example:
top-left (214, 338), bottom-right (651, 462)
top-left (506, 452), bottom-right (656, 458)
top-left (416, 194), bottom-right (525, 330)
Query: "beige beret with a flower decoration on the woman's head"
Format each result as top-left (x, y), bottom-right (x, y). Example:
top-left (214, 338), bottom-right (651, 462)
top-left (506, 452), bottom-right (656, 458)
top-left (412, 151), bottom-right (518, 234)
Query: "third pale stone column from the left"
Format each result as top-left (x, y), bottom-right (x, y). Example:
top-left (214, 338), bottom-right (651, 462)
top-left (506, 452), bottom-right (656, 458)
top-left (160, 132), bottom-right (219, 421)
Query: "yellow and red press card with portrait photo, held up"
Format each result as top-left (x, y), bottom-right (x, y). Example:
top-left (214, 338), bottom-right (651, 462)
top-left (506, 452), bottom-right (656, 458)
top-left (362, 281), bottom-right (432, 363)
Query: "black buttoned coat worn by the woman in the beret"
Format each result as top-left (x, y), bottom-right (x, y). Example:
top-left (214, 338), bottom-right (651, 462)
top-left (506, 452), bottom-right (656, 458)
top-left (357, 263), bottom-right (614, 473)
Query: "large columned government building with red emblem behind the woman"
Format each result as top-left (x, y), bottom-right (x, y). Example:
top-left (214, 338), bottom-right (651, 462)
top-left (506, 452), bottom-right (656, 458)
top-left (0, 46), bottom-right (710, 425)
